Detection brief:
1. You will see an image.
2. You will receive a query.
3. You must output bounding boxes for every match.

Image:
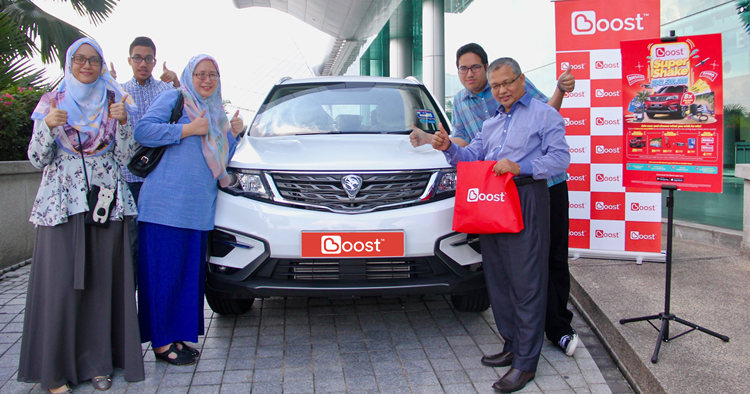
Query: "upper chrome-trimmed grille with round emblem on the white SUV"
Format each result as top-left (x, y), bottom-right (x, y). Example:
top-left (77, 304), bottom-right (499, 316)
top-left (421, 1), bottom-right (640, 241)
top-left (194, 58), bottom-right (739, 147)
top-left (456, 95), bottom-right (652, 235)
top-left (269, 171), bottom-right (436, 213)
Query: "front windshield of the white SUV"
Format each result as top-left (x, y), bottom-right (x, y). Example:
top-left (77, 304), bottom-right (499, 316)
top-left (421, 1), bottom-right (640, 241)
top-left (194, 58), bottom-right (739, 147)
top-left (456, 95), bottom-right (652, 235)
top-left (250, 82), bottom-right (446, 137)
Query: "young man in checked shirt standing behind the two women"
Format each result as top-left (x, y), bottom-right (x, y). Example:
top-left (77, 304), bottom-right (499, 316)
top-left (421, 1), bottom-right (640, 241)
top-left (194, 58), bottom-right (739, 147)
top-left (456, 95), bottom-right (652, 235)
top-left (117, 37), bottom-right (180, 278)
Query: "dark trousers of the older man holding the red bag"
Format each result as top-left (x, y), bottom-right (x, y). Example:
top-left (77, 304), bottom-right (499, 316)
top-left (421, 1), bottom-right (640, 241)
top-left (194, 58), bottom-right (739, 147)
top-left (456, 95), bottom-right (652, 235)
top-left (480, 180), bottom-right (550, 372)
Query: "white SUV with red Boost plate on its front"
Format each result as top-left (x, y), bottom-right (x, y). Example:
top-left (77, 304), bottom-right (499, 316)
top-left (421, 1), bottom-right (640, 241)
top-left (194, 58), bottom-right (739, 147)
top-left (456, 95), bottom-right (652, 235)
top-left (206, 77), bottom-right (489, 314)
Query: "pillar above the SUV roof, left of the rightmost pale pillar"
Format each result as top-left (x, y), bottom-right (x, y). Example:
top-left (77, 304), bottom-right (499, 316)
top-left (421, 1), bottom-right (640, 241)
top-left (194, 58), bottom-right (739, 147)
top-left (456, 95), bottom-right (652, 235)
top-left (389, 1), bottom-right (414, 78)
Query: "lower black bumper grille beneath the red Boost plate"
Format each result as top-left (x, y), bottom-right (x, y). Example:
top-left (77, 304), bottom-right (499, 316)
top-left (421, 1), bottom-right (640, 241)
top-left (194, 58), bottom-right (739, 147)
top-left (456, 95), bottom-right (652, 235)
top-left (272, 258), bottom-right (435, 282)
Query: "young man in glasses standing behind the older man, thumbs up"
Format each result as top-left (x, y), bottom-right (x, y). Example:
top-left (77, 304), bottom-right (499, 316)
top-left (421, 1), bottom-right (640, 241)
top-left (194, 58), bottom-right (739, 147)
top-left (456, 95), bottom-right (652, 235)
top-left (410, 43), bottom-right (578, 367)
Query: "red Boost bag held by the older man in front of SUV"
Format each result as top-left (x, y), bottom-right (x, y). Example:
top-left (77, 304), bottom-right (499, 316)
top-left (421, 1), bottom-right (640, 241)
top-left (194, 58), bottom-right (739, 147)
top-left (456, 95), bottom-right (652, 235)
top-left (453, 161), bottom-right (523, 234)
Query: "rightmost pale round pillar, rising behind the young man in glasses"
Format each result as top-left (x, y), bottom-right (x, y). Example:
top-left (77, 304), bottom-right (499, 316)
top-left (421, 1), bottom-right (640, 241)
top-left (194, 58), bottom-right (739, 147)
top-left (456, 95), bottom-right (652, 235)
top-left (422, 0), bottom-right (445, 108)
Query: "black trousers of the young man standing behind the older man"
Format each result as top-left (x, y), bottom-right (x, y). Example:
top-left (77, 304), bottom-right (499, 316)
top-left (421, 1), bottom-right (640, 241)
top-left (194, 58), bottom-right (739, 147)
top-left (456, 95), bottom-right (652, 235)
top-left (544, 181), bottom-right (573, 343)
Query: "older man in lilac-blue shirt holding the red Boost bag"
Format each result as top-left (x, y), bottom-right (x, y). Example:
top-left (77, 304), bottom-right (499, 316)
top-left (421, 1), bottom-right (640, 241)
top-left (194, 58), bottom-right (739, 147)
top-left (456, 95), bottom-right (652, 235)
top-left (432, 58), bottom-right (570, 393)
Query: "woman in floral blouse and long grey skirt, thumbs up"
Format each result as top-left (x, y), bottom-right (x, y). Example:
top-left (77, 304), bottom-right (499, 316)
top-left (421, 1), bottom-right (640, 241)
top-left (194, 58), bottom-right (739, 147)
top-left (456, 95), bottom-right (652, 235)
top-left (18, 38), bottom-right (144, 393)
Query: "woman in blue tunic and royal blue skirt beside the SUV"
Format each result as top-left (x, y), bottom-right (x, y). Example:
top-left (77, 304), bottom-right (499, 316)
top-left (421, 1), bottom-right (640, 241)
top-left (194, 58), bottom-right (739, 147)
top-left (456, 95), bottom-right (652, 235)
top-left (135, 55), bottom-right (243, 365)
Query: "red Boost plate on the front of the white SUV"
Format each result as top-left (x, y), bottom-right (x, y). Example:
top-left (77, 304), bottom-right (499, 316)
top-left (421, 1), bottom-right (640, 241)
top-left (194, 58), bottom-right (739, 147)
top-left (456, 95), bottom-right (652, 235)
top-left (302, 231), bottom-right (404, 258)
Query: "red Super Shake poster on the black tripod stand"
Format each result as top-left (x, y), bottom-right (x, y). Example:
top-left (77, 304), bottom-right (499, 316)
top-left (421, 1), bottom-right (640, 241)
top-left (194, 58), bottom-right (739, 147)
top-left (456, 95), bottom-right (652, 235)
top-left (621, 34), bottom-right (724, 193)
